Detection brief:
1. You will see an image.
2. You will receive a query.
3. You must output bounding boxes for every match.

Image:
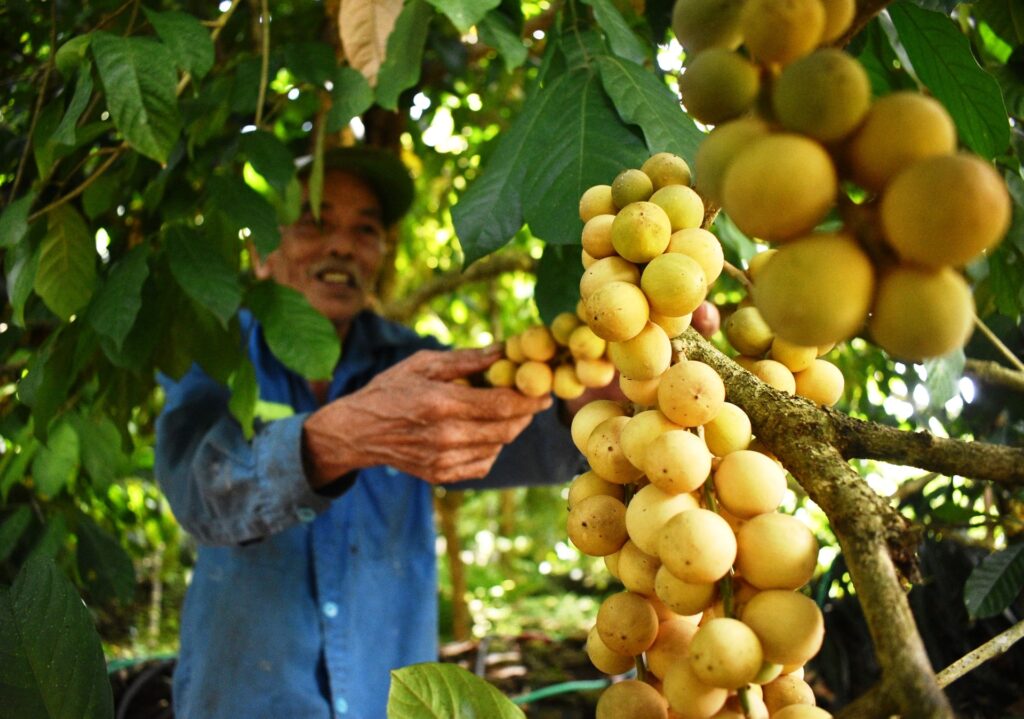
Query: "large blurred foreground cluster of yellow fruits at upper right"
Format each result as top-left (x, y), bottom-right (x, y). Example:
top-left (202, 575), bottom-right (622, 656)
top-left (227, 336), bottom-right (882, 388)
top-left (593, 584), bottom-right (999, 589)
top-left (673, 0), bottom-right (1011, 361)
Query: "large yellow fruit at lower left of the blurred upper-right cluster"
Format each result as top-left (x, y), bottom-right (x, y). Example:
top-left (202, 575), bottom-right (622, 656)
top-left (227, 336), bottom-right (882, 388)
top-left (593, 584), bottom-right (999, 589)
top-left (754, 235), bottom-right (874, 345)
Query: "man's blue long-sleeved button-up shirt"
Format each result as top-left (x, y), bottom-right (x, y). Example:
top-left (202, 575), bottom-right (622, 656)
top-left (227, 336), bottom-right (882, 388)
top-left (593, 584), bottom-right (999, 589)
top-left (156, 312), bottom-right (581, 719)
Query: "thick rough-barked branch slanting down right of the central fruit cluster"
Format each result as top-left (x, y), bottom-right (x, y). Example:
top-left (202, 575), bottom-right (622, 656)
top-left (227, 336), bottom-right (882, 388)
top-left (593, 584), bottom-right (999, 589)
top-left (682, 329), bottom-right (953, 719)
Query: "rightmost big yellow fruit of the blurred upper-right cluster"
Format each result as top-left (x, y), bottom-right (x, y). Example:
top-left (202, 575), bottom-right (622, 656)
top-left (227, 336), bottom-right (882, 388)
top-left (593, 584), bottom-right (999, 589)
top-left (881, 153), bottom-right (1011, 267)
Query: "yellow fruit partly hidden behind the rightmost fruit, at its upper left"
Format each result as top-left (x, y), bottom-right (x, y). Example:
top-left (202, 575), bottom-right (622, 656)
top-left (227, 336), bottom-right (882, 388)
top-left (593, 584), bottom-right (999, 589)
top-left (846, 91), bottom-right (956, 193)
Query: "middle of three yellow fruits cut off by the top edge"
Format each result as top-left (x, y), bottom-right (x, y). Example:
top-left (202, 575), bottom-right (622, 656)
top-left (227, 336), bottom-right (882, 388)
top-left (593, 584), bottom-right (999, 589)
top-left (739, 0), bottom-right (825, 65)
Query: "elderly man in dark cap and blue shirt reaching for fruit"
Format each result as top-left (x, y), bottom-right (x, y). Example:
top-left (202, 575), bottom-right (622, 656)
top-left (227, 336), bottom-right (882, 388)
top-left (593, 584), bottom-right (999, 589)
top-left (156, 150), bottom-right (580, 719)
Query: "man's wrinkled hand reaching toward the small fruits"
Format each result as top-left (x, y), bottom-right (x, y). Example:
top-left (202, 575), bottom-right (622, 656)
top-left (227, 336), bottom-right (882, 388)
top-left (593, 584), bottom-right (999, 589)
top-left (304, 348), bottom-right (551, 487)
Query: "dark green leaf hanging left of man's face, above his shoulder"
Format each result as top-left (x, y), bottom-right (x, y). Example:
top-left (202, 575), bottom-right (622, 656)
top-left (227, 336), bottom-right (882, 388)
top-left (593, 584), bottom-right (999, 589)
top-left (164, 225), bottom-right (242, 327)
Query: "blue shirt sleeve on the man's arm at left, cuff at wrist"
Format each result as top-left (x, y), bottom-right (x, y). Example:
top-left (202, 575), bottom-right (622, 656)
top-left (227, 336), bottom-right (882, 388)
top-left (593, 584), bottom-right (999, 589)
top-left (155, 368), bottom-right (331, 545)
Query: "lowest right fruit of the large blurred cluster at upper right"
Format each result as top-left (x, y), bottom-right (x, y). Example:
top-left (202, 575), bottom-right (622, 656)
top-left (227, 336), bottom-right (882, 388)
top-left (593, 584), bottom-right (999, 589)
top-left (867, 265), bottom-right (974, 362)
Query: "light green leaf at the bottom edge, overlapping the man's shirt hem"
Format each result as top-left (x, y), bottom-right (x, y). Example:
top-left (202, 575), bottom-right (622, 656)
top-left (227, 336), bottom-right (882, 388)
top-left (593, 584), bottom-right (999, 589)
top-left (387, 662), bottom-right (525, 719)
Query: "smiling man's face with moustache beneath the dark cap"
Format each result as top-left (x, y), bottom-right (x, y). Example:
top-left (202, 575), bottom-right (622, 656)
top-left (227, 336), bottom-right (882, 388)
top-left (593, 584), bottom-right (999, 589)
top-left (257, 170), bottom-right (385, 335)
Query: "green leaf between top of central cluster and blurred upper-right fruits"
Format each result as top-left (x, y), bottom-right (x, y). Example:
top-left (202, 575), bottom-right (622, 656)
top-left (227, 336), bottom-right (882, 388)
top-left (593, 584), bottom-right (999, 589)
top-left (598, 55), bottom-right (703, 163)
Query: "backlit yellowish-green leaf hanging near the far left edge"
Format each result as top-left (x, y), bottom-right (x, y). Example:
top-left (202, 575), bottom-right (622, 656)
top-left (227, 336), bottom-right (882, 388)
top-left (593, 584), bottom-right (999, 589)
top-left (35, 205), bottom-right (96, 320)
